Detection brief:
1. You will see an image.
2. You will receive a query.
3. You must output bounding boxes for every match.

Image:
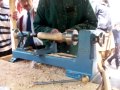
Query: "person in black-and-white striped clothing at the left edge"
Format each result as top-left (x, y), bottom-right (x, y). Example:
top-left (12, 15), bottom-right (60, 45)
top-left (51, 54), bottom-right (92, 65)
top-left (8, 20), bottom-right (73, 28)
top-left (0, 0), bottom-right (12, 57)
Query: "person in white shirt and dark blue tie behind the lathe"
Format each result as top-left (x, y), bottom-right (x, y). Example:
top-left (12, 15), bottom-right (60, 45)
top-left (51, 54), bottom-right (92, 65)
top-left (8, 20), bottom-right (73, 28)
top-left (18, 0), bottom-right (42, 48)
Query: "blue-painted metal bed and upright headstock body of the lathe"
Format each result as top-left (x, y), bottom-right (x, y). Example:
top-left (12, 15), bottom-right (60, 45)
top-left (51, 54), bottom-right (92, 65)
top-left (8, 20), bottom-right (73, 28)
top-left (11, 30), bottom-right (97, 79)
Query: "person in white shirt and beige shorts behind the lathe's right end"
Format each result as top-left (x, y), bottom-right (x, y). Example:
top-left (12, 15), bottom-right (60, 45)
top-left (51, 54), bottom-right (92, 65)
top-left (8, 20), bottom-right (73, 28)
top-left (95, 0), bottom-right (115, 60)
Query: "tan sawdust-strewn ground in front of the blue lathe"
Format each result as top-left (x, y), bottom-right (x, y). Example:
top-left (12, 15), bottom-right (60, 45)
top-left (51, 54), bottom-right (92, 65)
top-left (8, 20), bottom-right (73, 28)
top-left (0, 54), bottom-right (98, 90)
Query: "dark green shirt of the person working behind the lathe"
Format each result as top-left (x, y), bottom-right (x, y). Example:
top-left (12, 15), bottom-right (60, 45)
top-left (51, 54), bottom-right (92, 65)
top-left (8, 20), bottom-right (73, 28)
top-left (34, 0), bottom-right (97, 53)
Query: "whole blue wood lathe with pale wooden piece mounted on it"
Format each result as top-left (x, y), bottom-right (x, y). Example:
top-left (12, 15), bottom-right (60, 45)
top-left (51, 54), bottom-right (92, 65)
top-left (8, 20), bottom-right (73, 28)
top-left (10, 30), bottom-right (114, 86)
